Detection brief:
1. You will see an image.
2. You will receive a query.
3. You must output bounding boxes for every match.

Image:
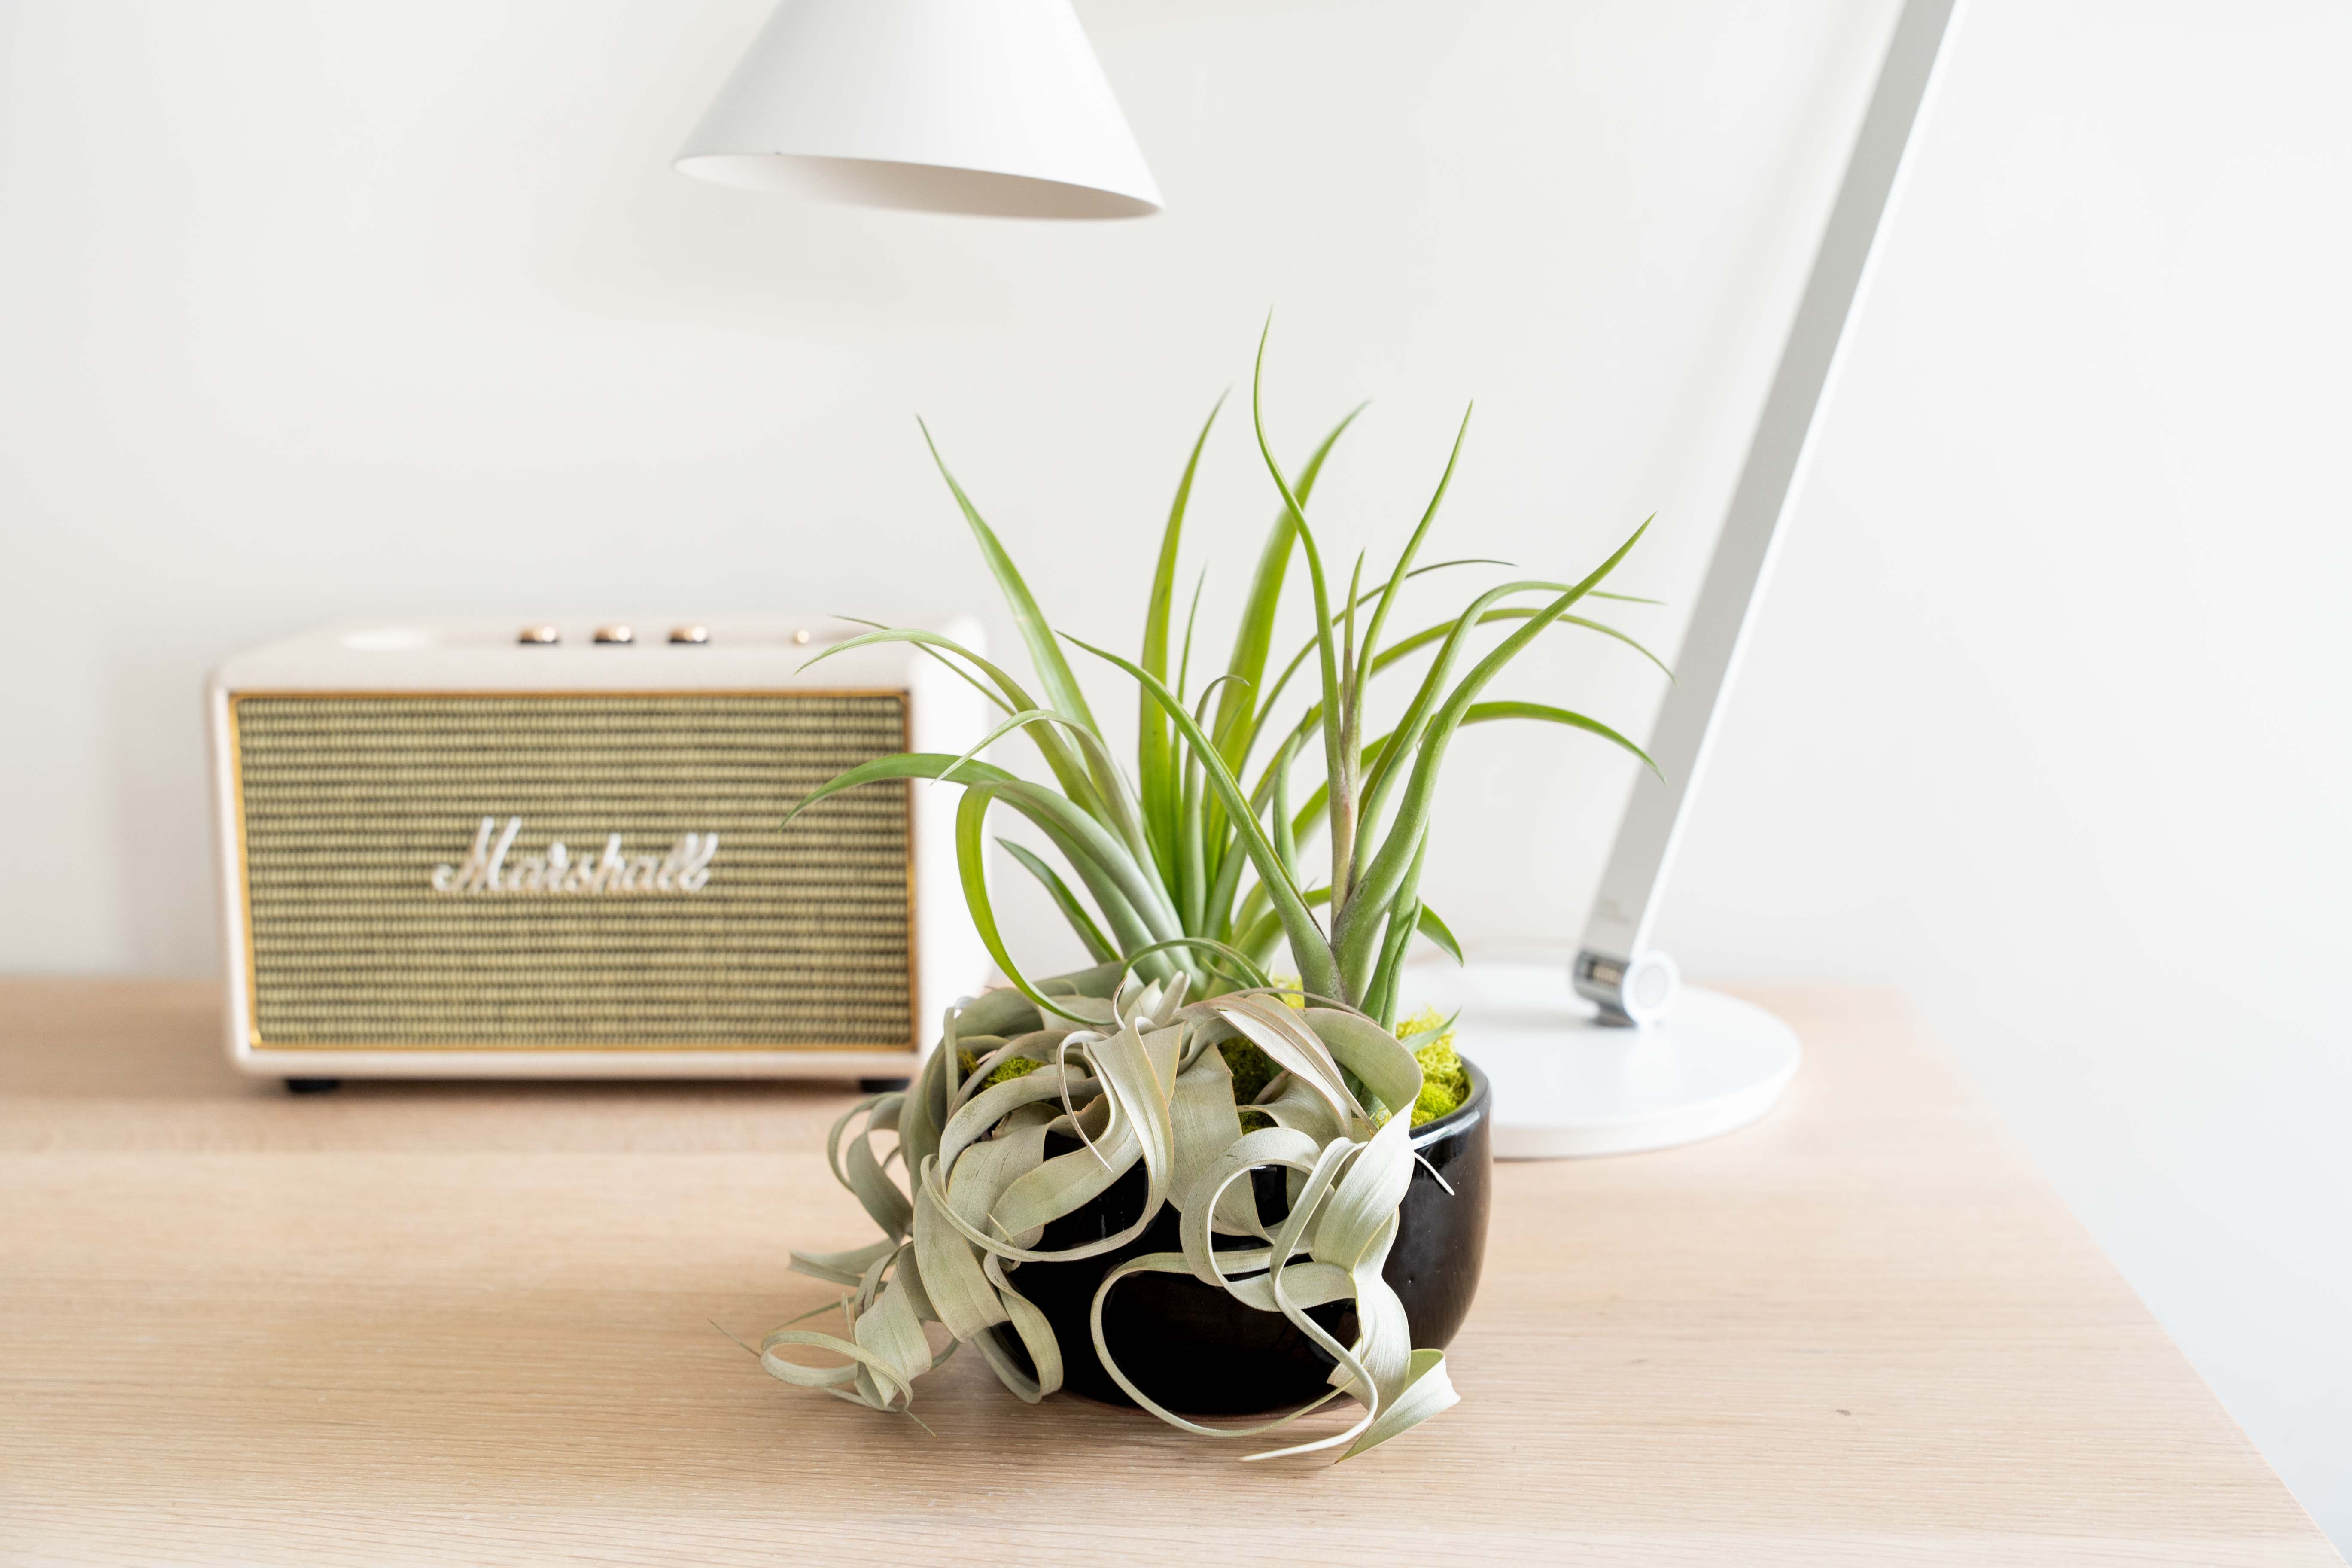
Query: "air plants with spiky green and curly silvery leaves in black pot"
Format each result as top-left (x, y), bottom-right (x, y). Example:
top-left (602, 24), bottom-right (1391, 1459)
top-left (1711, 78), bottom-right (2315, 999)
top-left (760, 324), bottom-right (1663, 1458)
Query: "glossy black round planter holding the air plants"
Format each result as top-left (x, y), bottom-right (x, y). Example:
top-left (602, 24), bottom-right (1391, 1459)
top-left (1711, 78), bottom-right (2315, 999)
top-left (1007, 1060), bottom-right (1494, 1415)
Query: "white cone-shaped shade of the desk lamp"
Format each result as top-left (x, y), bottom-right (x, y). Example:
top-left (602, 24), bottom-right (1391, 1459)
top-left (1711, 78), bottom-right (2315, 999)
top-left (677, 0), bottom-right (1159, 219)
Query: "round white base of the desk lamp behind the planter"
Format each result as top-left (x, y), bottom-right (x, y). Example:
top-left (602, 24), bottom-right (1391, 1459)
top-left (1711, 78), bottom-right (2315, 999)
top-left (1402, 964), bottom-right (1801, 1159)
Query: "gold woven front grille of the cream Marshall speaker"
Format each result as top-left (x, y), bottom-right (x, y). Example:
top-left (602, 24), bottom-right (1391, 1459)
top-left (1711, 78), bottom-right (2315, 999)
top-left (231, 691), bottom-right (915, 1051)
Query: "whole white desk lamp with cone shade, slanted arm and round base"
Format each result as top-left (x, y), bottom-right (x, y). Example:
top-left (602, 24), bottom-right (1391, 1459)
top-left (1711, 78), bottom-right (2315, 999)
top-left (677, 0), bottom-right (1957, 1159)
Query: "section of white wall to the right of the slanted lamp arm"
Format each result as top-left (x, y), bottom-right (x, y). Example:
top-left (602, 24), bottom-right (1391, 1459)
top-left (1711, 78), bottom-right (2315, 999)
top-left (1661, 0), bottom-right (2352, 1549)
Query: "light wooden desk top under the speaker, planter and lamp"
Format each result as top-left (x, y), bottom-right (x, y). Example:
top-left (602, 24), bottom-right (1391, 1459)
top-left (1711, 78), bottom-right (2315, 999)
top-left (0, 980), bottom-right (2340, 1566)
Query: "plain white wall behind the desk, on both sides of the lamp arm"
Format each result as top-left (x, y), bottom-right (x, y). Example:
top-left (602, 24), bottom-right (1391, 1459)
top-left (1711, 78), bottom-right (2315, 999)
top-left (0, 0), bottom-right (2352, 1540)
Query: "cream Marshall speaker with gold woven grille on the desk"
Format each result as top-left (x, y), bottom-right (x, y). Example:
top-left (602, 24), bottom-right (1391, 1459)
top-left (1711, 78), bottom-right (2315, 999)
top-left (207, 621), bottom-right (988, 1079)
